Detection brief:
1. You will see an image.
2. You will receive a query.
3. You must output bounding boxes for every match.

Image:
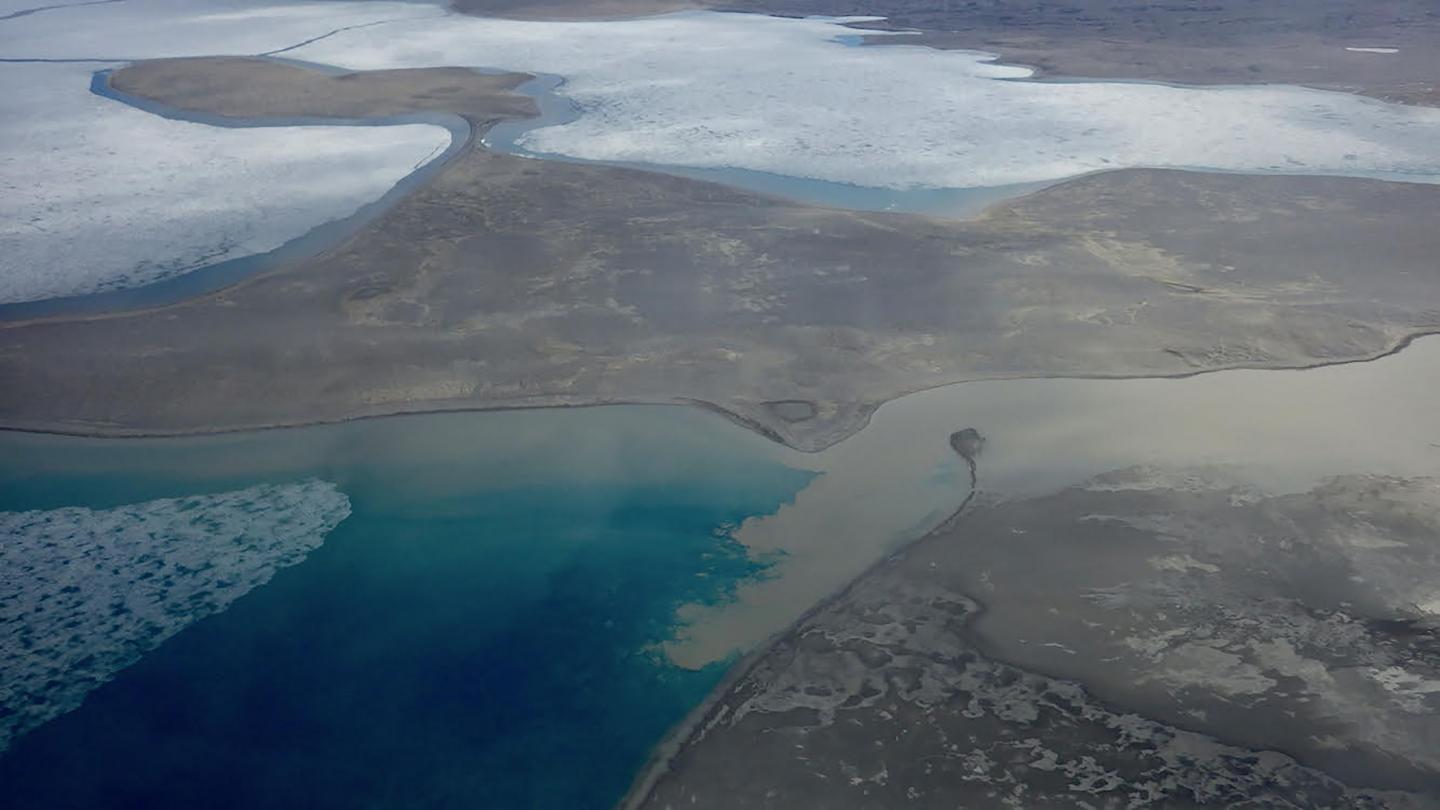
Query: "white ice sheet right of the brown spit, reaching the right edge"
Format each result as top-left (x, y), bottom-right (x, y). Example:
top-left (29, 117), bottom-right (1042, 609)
top-left (291, 12), bottom-right (1440, 189)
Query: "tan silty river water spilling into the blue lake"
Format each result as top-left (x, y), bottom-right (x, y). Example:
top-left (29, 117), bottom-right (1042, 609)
top-left (667, 331), bottom-right (1440, 667)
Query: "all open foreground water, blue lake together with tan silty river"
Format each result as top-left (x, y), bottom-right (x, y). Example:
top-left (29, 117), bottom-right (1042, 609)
top-left (0, 337), bottom-right (1440, 807)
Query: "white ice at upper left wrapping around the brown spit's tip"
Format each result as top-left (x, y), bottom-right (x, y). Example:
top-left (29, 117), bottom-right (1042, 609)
top-left (0, 1), bottom-right (451, 304)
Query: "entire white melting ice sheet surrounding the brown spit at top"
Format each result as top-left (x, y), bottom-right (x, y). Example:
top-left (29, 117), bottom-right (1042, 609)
top-left (0, 0), bottom-right (1440, 303)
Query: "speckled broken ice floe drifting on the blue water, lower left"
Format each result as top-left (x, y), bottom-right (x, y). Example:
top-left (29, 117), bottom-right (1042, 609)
top-left (0, 481), bottom-right (350, 751)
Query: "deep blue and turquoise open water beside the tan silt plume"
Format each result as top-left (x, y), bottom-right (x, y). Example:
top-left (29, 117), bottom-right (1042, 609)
top-left (0, 406), bottom-right (814, 809)
